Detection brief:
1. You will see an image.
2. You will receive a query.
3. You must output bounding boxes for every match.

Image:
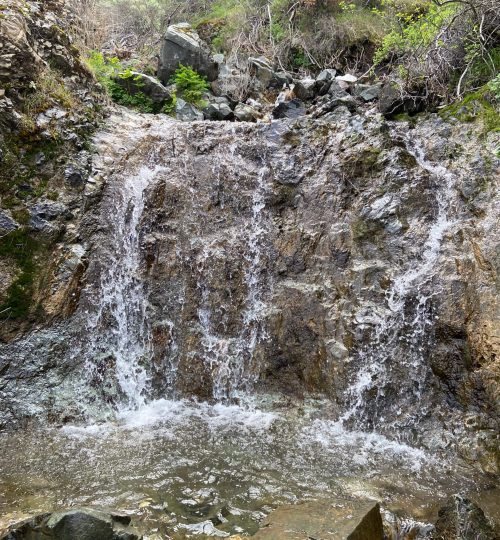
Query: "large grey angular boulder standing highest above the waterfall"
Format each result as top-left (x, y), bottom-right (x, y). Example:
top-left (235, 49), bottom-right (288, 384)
top-left (158, 23), bottom-right (219, 84)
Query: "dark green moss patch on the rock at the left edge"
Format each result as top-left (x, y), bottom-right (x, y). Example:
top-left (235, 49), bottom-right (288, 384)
top-left (0, 227), bottom-right (41, 320)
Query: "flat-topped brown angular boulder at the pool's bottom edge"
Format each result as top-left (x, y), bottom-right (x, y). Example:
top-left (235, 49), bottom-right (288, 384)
top-left (253, 499), bottom-right (384, 540)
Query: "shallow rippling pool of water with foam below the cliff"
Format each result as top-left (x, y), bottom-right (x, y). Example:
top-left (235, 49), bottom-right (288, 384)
top-left (0, 399), bottom-right (487, 538)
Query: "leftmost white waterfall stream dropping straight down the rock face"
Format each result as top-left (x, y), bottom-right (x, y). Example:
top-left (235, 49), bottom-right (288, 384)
top-left (84, 165), bottom-right (159, 407)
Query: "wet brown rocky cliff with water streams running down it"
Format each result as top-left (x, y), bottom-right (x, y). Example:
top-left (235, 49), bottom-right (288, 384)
top-left (0, 2), bottom-right (500, 472)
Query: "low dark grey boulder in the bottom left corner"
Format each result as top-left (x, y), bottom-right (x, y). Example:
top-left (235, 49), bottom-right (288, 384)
top-left (2, 508), bottom-right (142, 540)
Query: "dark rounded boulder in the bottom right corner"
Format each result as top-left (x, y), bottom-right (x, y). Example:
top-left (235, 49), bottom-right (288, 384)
top-left (434, 495), bottom-right (499, 540)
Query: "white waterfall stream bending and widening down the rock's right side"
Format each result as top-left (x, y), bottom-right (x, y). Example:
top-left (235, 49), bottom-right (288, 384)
top-left (341, 125), bottom-right (456, 429)
